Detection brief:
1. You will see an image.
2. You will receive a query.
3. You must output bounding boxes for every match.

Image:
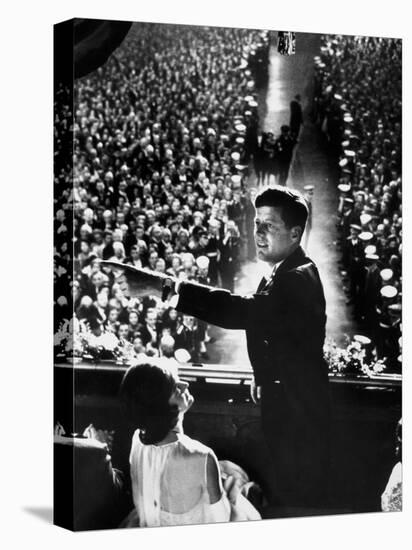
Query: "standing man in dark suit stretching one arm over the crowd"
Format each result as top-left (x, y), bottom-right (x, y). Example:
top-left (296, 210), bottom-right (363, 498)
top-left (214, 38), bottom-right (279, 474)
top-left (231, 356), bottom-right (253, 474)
top-left (103, 186), bottom-right (329, 516)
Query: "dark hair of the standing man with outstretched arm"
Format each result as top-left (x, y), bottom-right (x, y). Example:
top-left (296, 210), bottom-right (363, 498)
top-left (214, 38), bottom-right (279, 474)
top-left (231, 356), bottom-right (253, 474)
top-left (255, 185), bottom-right (308, 233)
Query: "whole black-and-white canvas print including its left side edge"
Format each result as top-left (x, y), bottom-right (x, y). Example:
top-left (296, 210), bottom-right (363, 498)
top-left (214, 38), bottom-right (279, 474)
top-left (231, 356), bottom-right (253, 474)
top-left (54, 18), bottom-right (402, 530)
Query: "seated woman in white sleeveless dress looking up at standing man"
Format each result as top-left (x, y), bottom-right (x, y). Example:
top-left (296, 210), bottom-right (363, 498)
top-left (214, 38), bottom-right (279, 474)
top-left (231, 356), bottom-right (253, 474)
top-left (120, 362), bottom-right (260, 527)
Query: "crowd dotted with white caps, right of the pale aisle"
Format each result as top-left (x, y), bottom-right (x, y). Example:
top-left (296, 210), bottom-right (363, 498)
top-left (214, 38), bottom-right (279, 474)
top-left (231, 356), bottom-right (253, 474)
top-left (315, 35), bottom-right (402, 370)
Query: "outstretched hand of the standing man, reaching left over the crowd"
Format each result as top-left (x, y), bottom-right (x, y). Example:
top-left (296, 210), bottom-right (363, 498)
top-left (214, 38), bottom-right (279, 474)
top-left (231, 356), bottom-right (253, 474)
top-left (100, 260), bottom-right (170, 298)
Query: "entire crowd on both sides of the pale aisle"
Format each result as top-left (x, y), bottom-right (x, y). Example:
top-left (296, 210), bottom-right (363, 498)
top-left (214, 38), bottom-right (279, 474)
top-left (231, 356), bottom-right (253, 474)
top-left (55, 28), bottom-right (402, 369)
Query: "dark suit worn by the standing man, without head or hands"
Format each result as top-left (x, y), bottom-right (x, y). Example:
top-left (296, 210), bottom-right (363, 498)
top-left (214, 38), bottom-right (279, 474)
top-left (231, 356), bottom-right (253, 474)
top-left (177, 247), bottom-right (329, 507)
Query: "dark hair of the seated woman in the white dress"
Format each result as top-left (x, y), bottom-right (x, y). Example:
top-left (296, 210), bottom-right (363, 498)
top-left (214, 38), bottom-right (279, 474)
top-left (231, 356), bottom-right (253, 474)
top-left (119, 363), bottom-right (179, 445)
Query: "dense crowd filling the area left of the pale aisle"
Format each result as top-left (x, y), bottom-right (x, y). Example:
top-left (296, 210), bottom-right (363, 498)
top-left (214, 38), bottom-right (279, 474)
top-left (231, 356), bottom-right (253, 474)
top-left (55, 23), bottom-right (269, 361)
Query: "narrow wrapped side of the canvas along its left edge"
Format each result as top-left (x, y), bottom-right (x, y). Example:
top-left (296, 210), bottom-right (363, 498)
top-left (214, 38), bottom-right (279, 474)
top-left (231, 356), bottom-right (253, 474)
top-left (53, 21), bottom-right (74, 529)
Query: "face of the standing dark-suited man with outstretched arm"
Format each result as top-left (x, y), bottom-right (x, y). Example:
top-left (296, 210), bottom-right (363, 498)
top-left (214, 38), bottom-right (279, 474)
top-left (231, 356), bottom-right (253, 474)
top-left (255, 206), bottom-right (300, 265)
